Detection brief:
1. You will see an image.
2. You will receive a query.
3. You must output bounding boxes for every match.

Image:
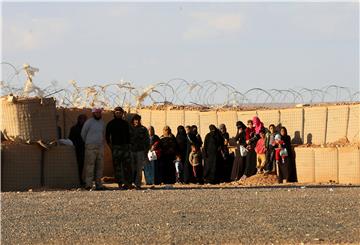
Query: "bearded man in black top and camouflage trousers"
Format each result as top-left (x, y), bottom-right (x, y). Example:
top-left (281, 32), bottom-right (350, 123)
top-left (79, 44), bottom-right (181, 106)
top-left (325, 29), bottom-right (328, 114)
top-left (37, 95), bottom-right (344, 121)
top-left (105, 107), bottom-right (132, 189)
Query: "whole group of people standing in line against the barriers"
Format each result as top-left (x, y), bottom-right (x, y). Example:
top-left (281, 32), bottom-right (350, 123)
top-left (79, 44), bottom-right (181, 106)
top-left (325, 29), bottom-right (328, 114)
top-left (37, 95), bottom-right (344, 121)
top-left (69, 107), bottom-right (296, 190)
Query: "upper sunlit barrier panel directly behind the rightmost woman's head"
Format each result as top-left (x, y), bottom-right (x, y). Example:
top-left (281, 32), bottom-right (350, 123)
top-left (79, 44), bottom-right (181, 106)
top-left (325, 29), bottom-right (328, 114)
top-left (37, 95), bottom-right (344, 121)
top-left (280, 108), bottom-right (304, 144)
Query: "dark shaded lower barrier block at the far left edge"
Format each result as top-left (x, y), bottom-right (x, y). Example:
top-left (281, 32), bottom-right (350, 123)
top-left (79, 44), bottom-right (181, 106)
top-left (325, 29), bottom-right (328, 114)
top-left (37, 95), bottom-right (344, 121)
top-left (1, 142), bottom-right (41, 191)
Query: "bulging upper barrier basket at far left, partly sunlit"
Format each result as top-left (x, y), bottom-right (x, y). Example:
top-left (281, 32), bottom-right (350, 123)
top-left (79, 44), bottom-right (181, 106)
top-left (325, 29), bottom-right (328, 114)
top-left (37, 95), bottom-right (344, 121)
top-left (0, 97), bottom-right (58, 142)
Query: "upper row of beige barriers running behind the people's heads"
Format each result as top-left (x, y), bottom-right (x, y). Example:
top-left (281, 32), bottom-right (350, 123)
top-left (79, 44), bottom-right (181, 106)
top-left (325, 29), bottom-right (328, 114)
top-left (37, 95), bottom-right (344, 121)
top-left (58, 104), bottom-right (360, 144)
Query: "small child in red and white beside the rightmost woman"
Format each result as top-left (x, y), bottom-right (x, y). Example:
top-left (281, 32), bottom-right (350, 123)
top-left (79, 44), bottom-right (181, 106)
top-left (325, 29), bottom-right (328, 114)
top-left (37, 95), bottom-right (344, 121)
top-left (274, 134), bottom-right (288, 183)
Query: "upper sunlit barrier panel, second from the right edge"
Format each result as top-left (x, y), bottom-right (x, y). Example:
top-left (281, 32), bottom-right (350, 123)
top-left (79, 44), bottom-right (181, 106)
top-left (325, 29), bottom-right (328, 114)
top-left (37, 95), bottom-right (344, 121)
top-left (326, 106), bottom-right (349, 143)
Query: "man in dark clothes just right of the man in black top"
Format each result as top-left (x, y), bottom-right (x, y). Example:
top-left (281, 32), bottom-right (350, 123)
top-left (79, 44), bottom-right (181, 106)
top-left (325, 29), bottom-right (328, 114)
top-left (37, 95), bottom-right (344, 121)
top-left (131, 114), bottom-right (150, 189)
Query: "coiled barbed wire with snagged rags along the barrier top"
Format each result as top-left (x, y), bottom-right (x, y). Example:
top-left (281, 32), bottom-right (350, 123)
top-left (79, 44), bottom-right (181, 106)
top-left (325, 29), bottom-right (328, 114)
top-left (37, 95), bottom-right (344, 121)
top-left (0, 62), bottom-right (360, 109)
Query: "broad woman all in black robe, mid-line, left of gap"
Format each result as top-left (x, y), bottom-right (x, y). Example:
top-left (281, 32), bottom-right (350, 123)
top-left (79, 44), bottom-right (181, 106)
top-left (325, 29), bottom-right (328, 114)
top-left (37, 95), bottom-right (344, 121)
top-left (204, 125), bottom-right (224, 184)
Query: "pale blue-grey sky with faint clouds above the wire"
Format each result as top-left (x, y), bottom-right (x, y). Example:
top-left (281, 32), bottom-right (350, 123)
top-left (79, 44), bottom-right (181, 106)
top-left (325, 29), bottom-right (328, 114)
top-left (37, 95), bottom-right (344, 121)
top-left (2, 1), bottom-right (359, 91)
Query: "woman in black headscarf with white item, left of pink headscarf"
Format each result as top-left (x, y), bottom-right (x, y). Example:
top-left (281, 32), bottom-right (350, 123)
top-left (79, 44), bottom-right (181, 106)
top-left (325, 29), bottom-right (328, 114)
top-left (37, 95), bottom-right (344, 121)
top-left (231, 121), bottom-right (246, 181)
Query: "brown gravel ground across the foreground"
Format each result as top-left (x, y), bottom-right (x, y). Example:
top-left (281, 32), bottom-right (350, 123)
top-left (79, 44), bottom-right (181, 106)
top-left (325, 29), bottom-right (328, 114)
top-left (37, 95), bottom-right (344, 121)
top-left (1, 186), bottom-right (360, 244)
